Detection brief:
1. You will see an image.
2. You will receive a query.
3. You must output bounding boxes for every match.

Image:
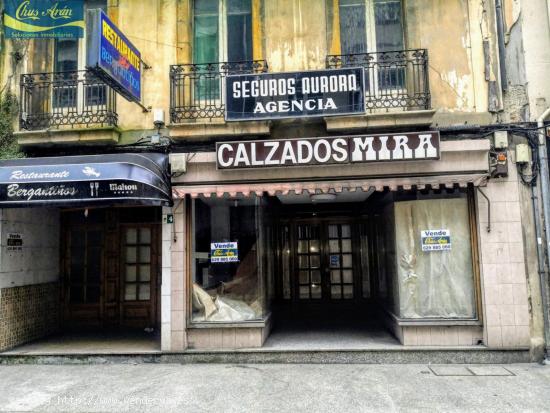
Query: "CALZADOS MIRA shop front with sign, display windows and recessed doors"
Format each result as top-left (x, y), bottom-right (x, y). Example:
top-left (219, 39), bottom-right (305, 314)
top-left (168, 131), bottom-right (504, 349)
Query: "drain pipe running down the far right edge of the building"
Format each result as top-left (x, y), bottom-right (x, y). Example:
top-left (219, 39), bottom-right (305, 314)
top-left (535, 107), bottom-right (550, 353)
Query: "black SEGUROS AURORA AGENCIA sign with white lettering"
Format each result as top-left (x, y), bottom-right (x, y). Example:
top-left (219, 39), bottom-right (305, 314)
top-left (225, 67), bottom-right (365, 121)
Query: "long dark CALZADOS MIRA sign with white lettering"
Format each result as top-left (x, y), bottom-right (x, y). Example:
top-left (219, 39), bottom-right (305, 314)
top-left (216, 131), bottom-right (440, 169)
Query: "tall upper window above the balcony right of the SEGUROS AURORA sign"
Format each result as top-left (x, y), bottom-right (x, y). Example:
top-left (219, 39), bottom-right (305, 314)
top-left (339, 0), bottom-right (404, 55)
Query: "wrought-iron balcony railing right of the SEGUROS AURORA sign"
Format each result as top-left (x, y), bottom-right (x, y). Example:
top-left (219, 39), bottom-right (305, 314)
top-left (326, 49), bottom-right (431, 112)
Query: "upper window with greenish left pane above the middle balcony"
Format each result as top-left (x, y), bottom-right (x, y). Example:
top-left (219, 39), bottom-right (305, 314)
top-left (193, 0), bottom-right (252, 63)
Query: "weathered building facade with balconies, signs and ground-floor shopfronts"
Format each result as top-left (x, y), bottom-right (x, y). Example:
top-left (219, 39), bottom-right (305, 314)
top-left (0, 0), bottom-right (550, 358)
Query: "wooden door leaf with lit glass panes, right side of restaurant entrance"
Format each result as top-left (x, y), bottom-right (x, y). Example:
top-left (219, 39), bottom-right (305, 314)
top-left (120, 224), bottom-right (160, 328)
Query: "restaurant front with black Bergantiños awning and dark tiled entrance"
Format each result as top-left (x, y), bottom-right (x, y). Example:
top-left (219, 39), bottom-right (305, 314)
top-left (0, 153), bottom-right (171, 352)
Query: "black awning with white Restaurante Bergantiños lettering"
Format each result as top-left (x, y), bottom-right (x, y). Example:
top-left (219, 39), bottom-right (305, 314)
top-left (0, 153), bottom-right (172, 208)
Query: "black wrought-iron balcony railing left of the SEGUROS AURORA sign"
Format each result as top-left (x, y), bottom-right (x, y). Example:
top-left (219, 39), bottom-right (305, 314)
top-left (170, 60), bottom-right (267, 123)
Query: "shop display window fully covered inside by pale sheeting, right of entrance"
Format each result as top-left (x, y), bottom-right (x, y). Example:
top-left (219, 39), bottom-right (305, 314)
top-left (393, 193), bottom-right (476, 319)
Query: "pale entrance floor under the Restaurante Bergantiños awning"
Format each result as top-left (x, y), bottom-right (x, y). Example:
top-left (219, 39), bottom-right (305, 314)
top-left (1, 331), bottom-right (160, 355)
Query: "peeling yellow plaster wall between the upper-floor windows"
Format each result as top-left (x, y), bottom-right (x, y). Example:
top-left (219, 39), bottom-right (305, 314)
top-left (3, 0), bottom-right (516, 132)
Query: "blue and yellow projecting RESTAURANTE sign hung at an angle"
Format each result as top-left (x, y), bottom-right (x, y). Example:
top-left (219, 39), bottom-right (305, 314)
top-left (86, 9), bottom-right (141, 102)
